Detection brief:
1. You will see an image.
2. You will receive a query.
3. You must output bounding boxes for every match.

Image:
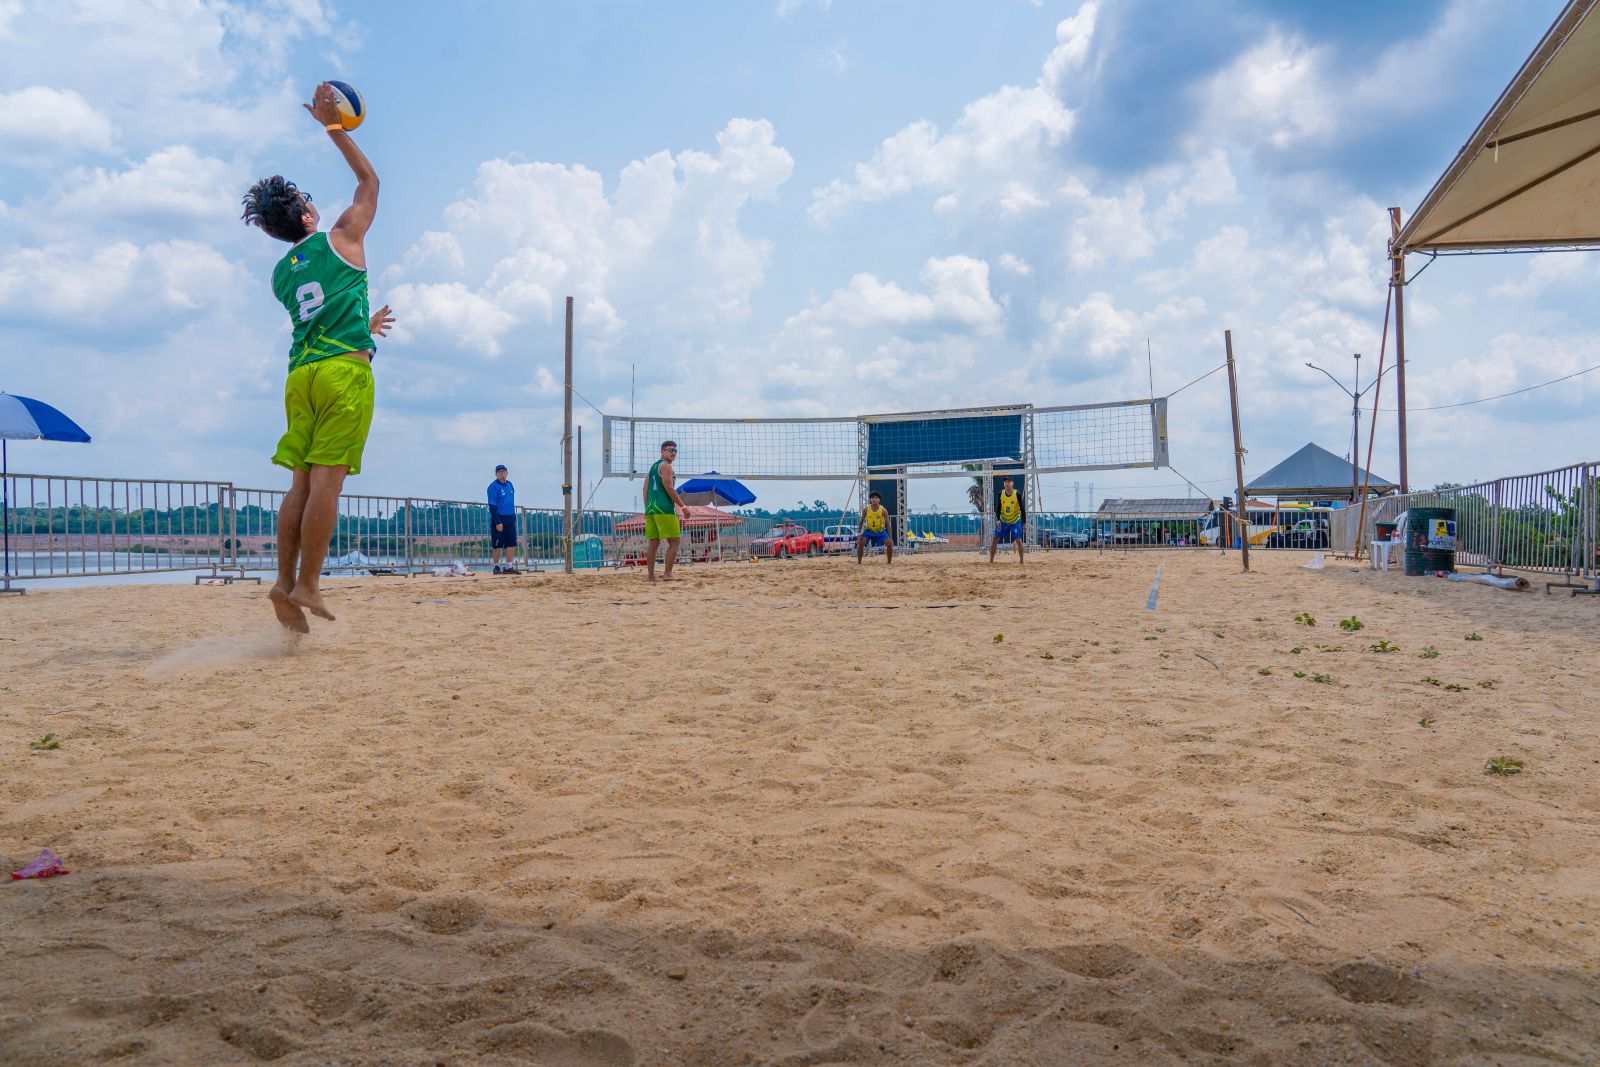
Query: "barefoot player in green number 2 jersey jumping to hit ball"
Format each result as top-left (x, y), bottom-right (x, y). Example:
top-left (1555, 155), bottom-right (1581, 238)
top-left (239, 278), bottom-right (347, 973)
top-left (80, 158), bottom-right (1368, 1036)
top-left (243, 82), bottom-right (394, 633)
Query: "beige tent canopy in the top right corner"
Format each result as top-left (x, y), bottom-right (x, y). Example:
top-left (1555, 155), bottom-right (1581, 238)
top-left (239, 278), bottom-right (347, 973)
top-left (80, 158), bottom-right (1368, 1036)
top-left (1394, 0), bottom-right (1600, 254)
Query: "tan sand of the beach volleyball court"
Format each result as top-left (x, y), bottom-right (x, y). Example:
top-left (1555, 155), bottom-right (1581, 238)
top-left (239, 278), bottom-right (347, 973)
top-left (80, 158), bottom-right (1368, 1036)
top-left (0, 552), bottom-right (1600, 1067)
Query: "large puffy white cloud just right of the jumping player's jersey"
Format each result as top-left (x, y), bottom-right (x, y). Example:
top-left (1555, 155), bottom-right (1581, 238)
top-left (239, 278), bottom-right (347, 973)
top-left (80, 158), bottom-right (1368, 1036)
top-left (384, 118), bottom-right (794, 364)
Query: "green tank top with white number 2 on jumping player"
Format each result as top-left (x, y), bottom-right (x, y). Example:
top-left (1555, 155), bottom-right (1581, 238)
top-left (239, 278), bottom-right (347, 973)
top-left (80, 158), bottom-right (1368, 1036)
top-left (272, 230), bottom-right (378, 371)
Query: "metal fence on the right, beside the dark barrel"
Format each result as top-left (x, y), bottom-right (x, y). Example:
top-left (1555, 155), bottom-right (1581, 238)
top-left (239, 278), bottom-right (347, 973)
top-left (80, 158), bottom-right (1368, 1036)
top-left (1333, 462), bottom-right (1600, 581)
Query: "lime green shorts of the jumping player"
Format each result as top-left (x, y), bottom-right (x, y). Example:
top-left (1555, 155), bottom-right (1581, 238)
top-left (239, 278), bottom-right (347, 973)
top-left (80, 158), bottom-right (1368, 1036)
top-left (272, 355), bottom-right (373, 474)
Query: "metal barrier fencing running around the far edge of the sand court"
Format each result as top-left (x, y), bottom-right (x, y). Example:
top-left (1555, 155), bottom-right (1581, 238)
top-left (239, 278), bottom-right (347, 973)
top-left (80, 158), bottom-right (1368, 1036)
top-left (3, 464), bottom-right (1600, 585)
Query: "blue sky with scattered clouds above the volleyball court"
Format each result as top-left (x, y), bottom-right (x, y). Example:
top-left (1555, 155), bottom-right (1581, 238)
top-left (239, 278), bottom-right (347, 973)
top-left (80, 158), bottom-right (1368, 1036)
top-left (0, 0), bottom-right (1600, 507)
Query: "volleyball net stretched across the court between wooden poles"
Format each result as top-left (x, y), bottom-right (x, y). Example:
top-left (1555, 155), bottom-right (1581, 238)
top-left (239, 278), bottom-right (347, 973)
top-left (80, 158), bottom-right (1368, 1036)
top-left (603, 397), bottom-right (1170, 482)
